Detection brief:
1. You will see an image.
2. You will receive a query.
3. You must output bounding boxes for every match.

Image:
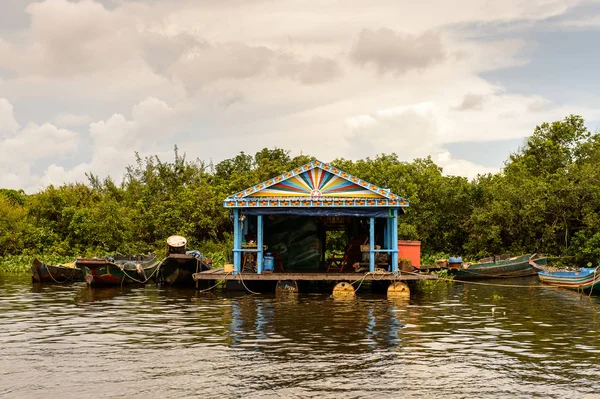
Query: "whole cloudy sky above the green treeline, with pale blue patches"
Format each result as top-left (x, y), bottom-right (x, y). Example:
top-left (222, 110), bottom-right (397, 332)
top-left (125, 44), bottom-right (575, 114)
top-left (0, 0), bottom-right (600, 192)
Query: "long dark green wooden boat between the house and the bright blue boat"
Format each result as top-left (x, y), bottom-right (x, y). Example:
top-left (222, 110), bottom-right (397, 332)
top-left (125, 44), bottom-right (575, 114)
top-left (448, 254), bottom-right (547, 280)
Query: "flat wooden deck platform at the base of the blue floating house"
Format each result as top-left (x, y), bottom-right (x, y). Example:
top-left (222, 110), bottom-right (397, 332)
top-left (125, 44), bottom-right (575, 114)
top-left (193, 269), bottom-right (436, 281)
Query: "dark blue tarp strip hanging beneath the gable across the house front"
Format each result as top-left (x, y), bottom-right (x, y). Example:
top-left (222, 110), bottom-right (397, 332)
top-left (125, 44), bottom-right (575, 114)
top-left (243, 208), bottom-right (404, 218)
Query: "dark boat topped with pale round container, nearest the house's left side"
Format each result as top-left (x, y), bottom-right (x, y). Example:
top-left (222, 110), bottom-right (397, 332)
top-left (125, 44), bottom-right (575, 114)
top-left (159, 236), bottom-right (212, 285)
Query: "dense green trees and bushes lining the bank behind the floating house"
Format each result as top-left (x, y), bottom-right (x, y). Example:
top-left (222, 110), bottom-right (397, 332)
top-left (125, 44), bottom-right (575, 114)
top-left (0, 116), bottom-right (600, 272)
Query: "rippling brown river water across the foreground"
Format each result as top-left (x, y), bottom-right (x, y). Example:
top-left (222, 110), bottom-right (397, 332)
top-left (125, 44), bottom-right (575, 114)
top-left (0, 275), bottom-right (600, 399)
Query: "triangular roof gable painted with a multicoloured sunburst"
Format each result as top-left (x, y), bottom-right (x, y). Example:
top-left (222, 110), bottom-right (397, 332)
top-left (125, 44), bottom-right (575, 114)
top-left (224, 160), bottom-right (408, 208)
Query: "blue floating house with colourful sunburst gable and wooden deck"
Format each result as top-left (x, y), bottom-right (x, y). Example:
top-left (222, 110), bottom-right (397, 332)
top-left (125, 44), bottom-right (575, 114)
top-left (194, 160), bottom-right (431, 293)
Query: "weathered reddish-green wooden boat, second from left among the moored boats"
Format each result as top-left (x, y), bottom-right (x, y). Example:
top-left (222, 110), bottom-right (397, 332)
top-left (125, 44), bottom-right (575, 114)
top-left (75, 254), bottom-right (159, 286)
